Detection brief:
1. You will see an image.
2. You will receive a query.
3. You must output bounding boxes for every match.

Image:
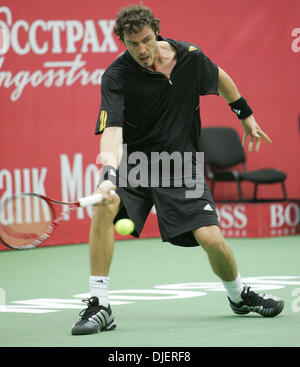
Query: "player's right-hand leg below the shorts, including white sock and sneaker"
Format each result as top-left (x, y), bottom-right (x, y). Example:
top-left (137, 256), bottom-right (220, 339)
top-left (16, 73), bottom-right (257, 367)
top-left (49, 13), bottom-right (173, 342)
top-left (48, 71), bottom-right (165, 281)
top-left (193, 226), bottom-right (284, 317)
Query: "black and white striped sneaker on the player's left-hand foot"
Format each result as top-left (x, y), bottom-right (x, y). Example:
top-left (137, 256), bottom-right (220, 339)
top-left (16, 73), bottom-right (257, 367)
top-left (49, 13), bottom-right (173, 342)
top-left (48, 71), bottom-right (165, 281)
top-left (72, 297), bottom-right (117, 335)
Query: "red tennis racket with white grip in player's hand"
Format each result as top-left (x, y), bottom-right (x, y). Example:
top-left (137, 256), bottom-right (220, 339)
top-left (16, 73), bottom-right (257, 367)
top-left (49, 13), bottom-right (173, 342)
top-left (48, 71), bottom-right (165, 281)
top-left (0, 193), bottom-right (112, 249)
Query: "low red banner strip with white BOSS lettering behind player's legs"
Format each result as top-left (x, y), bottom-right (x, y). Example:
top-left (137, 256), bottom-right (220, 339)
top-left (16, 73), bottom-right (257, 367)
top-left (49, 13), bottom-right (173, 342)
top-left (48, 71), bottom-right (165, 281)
top-left (0, 201), bottom-right (300, 250)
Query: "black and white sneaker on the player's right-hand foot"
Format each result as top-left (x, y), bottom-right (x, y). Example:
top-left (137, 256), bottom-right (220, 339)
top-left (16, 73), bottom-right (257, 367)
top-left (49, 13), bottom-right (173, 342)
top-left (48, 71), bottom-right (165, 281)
top-left (228, 285), bottom-right (284, 317)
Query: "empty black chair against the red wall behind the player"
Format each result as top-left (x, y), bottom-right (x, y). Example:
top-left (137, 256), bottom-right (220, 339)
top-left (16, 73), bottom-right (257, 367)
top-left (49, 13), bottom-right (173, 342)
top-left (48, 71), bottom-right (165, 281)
top-left (200, 127), bottom-right (287, 201)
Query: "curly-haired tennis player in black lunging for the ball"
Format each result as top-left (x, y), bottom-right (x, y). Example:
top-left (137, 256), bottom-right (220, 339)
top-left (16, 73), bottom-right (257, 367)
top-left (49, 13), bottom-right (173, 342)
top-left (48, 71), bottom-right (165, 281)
top-left (72, 5), bottom-right (284, 335)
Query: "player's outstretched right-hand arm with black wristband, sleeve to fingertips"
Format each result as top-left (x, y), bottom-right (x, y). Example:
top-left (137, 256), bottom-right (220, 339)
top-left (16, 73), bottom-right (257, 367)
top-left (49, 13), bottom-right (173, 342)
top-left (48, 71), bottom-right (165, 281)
top-left (218, 68), bottom-right (272, 152)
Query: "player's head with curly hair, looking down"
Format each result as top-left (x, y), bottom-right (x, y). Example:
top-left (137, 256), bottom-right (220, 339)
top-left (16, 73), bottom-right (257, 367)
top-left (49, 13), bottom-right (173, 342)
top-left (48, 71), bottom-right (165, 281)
top-left (114, 5), bottom-right (160, 68)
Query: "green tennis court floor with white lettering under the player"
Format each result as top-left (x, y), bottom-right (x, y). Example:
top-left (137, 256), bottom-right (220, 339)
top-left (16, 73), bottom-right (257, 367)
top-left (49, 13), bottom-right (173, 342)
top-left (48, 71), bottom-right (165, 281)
top-left (0, 236), bottom-right (300, 348)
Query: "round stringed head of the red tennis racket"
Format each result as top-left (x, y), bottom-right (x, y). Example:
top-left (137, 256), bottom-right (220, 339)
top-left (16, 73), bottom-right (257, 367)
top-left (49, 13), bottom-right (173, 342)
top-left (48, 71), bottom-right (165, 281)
top-left (0, 195), bottom-right (54, 248)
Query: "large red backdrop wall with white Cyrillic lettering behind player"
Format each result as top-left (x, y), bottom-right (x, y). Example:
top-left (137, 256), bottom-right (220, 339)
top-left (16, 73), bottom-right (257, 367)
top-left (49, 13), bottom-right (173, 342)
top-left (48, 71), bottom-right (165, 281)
top-left (0, 0), bottom-right (300, 250)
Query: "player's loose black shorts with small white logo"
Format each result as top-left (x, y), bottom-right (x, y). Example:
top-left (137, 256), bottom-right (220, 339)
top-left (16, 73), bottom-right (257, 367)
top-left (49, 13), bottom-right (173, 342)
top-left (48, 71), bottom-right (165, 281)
top-left (114, 183), bottom-right (219, 247)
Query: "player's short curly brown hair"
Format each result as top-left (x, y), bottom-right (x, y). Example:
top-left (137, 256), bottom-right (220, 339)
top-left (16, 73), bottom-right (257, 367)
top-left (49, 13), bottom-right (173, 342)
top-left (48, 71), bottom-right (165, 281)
top-left (114, 5), bottom-right (160, 42)
